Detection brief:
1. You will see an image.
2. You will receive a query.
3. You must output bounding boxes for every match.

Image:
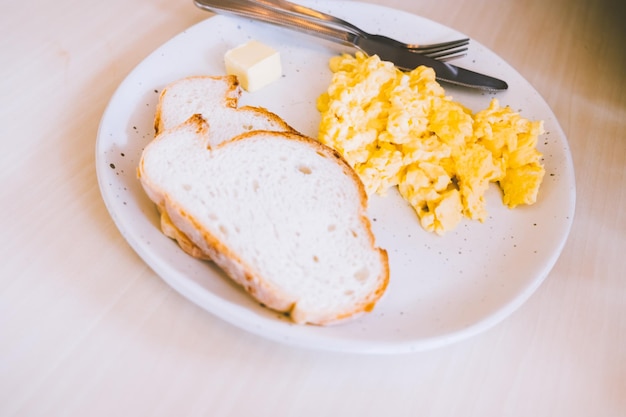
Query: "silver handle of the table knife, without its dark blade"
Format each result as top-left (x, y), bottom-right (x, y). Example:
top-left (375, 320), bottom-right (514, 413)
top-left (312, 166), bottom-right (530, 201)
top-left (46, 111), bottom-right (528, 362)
top-left (194, 0), bottom-right (357, 47)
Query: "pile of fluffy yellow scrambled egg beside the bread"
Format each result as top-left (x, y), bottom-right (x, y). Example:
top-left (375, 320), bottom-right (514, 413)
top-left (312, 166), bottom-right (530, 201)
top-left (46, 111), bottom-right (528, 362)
top-left (317, 53), bottom-right (545, 234)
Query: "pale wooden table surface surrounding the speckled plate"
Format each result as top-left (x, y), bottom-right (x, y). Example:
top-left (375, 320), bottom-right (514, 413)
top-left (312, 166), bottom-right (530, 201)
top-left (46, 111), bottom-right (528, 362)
top-left (0, 0), bottom-right (626, 417)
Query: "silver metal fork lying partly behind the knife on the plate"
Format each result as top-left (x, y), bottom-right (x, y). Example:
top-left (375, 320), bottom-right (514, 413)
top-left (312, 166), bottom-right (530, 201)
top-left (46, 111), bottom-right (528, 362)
top-left (256, 0), bottom-right (469, 60)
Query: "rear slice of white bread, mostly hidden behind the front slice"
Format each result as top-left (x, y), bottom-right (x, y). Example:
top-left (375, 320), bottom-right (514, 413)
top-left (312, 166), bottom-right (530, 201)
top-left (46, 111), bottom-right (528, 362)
top-left (154, 75), bottom-right (295, 141)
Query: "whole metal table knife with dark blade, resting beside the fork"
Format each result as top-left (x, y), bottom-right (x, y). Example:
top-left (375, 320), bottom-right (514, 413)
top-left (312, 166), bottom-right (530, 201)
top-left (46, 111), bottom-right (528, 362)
top-left (194, 0), bottom-right (508, 91)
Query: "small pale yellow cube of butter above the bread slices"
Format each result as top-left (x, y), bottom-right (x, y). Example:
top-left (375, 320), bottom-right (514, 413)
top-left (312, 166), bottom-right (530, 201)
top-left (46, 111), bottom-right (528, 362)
top-left (224, 40), bottom-right (282, 92)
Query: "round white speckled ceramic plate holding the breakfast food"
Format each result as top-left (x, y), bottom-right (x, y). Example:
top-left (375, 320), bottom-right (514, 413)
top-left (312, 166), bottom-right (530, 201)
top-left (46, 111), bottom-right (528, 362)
top-left (96, 0), bottom-right (575, 353)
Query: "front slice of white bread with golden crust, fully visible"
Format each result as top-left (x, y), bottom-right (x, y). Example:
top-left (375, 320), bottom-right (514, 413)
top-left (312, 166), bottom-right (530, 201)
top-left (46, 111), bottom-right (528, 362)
top-left (138, 115), bottom-right (389, 325)
